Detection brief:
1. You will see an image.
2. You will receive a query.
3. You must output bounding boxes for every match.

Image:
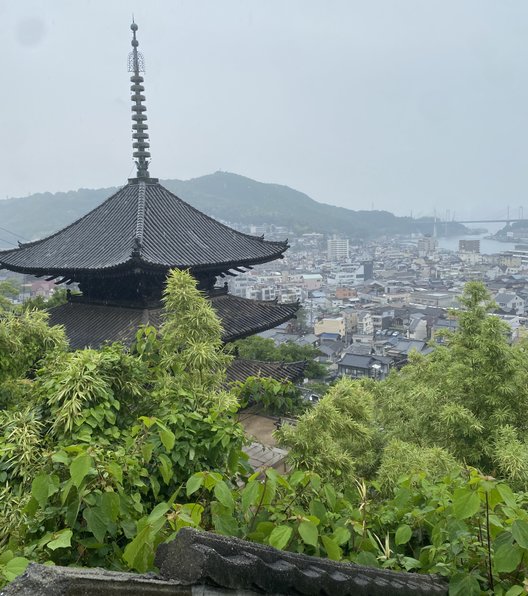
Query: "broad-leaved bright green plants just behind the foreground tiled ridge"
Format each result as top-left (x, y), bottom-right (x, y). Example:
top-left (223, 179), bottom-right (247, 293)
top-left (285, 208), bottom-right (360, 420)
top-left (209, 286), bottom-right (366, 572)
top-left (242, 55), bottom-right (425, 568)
top-left (6, 464), bottom-right (528, 595)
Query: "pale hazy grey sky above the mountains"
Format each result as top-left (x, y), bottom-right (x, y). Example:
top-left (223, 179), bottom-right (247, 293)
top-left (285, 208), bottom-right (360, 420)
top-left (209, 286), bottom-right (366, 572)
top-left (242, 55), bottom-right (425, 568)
top-left (0, 0), bottom-right (528, 216)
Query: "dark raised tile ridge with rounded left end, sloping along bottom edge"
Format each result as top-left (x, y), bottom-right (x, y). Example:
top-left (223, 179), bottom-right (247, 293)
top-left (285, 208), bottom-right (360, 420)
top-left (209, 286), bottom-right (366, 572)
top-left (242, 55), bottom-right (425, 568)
top-left (155, 528), bottom-right (448, 596)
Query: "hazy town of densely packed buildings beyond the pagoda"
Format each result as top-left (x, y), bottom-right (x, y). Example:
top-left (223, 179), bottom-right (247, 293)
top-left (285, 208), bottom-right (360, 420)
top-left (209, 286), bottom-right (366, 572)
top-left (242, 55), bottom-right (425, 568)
top-left (4, 223), bottom-right (528, 379)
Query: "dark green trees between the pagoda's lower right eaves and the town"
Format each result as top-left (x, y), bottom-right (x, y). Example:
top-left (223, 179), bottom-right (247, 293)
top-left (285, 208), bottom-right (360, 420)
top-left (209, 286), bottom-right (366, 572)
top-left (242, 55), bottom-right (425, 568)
top-left (235, 335), bottom-right (327, 379)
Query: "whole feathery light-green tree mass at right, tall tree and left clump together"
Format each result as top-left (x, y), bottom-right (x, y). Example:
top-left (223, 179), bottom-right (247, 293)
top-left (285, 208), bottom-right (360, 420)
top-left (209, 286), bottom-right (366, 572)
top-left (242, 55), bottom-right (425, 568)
top-left (278, 282), bottom-right (528, 490)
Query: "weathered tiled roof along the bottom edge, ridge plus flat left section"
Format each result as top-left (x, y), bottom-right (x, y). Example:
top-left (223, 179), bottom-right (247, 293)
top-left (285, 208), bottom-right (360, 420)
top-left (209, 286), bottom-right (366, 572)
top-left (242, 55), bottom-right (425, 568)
top-left (2, 528), bottom-right (449, 596)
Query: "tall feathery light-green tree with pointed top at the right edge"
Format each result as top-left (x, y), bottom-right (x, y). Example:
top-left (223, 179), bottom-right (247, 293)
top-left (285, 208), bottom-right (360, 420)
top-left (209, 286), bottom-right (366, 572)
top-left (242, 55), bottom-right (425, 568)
top-left (372, 282), bottom-right (528, 487)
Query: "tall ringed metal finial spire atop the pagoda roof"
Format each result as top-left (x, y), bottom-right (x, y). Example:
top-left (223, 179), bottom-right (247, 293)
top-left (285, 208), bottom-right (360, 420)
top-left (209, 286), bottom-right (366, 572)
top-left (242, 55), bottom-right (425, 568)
top-left (128, 17), bottom-right (150, 179)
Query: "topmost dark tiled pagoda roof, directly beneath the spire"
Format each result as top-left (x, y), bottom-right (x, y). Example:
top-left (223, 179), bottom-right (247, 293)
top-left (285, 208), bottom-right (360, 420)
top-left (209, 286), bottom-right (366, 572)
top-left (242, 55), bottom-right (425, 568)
top-left (0, 179), bottom-right (288, 279)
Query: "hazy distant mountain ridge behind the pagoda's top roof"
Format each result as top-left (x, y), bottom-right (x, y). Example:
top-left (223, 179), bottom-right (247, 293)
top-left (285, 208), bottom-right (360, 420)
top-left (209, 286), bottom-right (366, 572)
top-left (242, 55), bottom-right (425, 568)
top-left (0, 172), bottom-right (465, 248)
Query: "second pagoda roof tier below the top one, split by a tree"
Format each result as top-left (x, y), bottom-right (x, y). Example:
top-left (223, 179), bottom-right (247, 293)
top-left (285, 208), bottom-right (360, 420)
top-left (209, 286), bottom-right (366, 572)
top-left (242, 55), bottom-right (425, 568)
top-left (49, 294), bottom-right (299, 350)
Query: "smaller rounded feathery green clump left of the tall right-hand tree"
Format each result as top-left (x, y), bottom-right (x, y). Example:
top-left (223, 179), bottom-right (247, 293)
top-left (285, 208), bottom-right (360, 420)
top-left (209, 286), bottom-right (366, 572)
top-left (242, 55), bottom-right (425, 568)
top-left (276, 377), bottom-right (380, 485)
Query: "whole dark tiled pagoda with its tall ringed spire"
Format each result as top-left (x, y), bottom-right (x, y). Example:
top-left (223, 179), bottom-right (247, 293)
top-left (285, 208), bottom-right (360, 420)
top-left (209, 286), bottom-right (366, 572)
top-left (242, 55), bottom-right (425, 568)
top-left (0, 23), bottom-right (299, 376)
